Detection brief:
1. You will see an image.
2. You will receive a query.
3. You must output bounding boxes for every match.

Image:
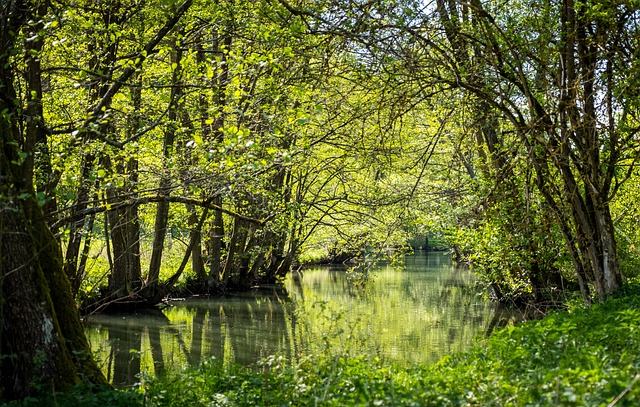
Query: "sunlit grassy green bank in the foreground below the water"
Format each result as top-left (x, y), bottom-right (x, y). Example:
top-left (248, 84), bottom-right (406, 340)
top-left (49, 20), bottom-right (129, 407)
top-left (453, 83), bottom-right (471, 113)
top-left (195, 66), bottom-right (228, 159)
top-left (6, 282), bottom-right (640, 406)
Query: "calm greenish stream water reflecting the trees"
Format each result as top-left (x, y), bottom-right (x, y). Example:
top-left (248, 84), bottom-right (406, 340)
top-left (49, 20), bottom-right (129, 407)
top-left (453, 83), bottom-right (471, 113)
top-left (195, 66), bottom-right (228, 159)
top-left (86, 253), bottom-right (501, 385)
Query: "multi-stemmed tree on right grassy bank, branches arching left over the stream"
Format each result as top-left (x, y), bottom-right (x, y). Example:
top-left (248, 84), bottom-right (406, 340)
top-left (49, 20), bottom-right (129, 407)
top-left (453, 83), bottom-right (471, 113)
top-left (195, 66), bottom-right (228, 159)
top-left (280, 0), bottom-right (639, 301)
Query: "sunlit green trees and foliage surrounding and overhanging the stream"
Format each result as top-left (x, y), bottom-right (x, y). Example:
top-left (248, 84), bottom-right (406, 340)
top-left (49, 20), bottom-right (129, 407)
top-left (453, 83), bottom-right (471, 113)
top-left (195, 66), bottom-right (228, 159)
top-left (0, 0), bottom-right (640, 399)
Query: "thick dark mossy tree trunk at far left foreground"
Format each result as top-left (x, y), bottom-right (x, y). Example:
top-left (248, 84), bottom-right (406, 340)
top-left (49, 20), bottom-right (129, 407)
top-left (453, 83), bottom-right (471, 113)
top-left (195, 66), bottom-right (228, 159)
top-left (0, 1), bottom-right (105, 399)
